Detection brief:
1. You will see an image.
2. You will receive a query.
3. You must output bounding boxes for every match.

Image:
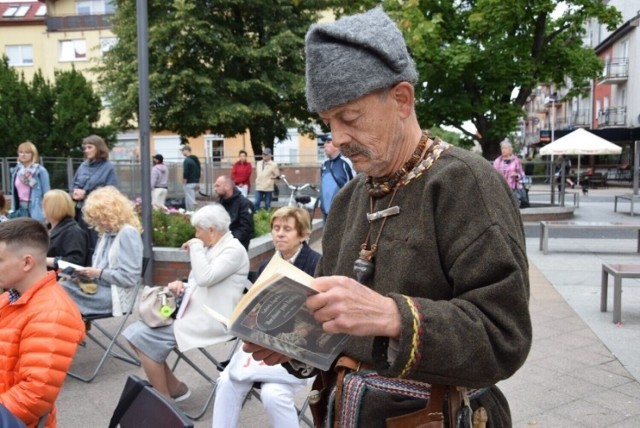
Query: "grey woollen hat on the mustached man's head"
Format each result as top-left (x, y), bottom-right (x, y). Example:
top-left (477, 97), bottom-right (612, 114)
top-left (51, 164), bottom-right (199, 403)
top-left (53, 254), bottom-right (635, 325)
top-left (305, 7), bottom-right (418, 112)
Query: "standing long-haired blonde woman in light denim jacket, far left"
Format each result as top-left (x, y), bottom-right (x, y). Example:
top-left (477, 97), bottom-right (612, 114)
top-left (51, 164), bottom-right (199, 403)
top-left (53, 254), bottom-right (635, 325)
top-left (11, 141), bottom-right (51, 222)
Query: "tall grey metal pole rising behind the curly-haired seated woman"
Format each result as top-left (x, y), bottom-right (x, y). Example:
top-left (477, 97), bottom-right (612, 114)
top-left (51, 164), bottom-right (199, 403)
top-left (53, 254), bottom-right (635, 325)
top-left (136, 0), bottom-right (153, 285)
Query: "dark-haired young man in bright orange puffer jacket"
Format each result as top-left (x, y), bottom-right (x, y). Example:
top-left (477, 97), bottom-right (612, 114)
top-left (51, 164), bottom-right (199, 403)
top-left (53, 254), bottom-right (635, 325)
top-left (0, 218), bottom-right (85, 427)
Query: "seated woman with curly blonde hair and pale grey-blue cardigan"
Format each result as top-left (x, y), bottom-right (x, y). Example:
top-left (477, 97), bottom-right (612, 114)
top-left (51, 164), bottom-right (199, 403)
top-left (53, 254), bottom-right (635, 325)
top-left (60, 186), bottom-right (143, 316)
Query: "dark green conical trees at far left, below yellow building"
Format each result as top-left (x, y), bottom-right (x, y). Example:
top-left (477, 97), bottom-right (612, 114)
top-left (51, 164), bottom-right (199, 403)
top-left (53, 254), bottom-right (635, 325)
top-left (0, 57), bottom-right (115, 156)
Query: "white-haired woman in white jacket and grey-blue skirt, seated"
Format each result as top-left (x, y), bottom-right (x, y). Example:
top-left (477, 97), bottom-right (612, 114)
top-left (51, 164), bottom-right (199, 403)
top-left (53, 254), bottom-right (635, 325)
top-left (123, 204), bottom-right (249, 401)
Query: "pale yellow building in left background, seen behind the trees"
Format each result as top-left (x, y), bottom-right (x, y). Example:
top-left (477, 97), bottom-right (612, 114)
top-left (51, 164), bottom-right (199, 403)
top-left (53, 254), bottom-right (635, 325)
top-left (0, 0), bottom-right (324, 166)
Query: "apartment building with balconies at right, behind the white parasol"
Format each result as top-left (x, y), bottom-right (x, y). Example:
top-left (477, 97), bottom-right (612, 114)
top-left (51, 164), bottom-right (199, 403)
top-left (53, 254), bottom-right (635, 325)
top-left (523, 0), bottom-right (640, 169)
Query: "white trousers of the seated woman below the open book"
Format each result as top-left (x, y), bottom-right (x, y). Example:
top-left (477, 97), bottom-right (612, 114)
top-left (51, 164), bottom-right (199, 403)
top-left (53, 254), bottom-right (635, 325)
top-left (213, 370), bottom-right (304, 428)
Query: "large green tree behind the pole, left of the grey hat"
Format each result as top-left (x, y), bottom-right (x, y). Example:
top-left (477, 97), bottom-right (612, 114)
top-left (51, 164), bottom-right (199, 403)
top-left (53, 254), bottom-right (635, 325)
top-left (97, 0), bottom-right (326, 153)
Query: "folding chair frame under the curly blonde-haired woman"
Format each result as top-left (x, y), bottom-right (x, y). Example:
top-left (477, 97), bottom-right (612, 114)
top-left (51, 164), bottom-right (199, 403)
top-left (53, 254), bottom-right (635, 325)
top-left (68, 257), bottom-right (149, 383)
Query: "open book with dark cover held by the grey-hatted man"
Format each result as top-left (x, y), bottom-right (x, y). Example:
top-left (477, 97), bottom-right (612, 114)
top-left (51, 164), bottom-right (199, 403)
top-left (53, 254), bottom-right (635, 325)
top-left (203, 257), bottom-right (349, 370)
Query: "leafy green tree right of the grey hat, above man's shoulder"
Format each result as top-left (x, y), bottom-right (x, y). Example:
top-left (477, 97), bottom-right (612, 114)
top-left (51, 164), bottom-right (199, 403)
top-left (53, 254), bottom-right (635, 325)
top-left (336, 0), bottom-right (621, 159)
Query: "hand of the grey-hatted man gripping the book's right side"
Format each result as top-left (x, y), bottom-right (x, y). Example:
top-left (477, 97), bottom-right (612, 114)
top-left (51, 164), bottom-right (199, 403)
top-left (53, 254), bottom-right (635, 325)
top-left (306, 276), bottom-right (402, 339)
